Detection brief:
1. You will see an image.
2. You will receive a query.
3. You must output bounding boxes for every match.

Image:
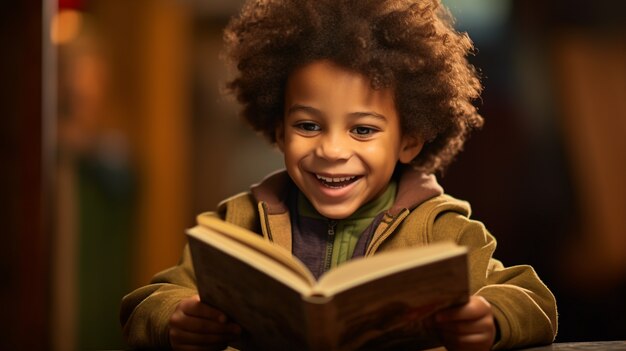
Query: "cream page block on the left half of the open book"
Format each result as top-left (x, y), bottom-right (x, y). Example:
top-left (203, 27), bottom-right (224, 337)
top-left (197, 215), bottom-right (316, 286)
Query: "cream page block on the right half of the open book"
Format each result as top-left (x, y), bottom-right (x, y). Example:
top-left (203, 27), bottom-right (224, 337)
top-left (314, 242), bottom-right (467, 296)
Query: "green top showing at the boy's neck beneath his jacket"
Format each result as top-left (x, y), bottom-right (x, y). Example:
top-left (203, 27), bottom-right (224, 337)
top-left (298, 181), bottom-right (397, 268)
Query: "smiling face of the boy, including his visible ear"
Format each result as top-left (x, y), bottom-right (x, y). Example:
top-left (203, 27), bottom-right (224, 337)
top-left (276, 60), bottom-right (422, 219)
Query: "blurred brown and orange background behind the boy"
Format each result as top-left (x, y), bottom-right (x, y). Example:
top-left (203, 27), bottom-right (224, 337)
top-left (0, 0), bottom-right (626, 350)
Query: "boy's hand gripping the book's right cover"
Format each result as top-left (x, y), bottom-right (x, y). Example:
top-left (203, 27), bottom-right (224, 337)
top-left (434, 296), bottom-right (496, 351)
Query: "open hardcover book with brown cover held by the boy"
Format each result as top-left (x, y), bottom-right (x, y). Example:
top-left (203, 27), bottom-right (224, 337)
top-left (187, 215), bottom-right (469, 350)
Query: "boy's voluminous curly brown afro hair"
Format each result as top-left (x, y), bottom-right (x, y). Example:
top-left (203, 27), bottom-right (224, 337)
top-left (224, 0), bottom-right (483, 173)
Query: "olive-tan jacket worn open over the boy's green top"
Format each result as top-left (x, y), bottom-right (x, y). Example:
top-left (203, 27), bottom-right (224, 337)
top-left (120, 173), bottom-right (557, 349)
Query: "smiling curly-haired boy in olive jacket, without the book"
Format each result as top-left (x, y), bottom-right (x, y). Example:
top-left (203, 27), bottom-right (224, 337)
top-left (121, 0), bottom-right (557, 350)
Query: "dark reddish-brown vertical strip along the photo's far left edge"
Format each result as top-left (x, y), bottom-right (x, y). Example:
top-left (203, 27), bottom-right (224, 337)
top-left (0, 1), bottom-right (50, 350)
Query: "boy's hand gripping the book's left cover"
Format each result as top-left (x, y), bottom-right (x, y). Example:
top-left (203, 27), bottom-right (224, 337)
top-left (169, 295), bottom-right (241, 350)
